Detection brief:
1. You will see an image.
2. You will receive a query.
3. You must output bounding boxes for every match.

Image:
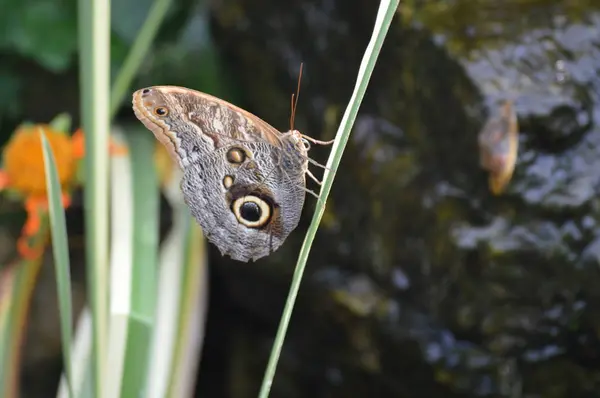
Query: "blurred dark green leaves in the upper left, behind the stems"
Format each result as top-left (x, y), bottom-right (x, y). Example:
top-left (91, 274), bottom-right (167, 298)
top-left (0, 0), bottom-right (230, 146)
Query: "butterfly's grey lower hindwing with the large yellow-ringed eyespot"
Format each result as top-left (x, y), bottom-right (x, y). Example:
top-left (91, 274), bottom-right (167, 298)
top-left (181, 143), bottom-right (305, 261)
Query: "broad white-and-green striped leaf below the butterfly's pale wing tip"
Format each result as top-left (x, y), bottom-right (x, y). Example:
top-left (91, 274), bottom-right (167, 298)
top-left (107, 129), bottom-right (159, 397)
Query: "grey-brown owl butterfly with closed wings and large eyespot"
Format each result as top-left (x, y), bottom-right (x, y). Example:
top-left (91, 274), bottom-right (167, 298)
top-left (133, 86), bottom-right (308, 261)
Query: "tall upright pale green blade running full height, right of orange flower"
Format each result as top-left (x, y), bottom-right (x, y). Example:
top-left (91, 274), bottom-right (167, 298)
top-left (78, 0), bottom-right (110, 398)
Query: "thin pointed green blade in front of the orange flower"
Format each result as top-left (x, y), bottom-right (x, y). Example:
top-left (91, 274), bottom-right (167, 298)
top-left (39, 129), bottom-right (73, 398)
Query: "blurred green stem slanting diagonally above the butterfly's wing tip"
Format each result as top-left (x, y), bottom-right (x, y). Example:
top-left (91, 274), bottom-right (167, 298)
top-left (110, 0), bottom-right (172, 119)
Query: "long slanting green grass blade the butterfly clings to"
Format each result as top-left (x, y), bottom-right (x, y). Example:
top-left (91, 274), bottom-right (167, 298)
top-left (259, 0), bottom-right (400, 398)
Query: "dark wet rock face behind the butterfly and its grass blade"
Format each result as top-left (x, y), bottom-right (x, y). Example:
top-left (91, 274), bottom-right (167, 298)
top-left (199, 0), bottom-right (600, 397)
